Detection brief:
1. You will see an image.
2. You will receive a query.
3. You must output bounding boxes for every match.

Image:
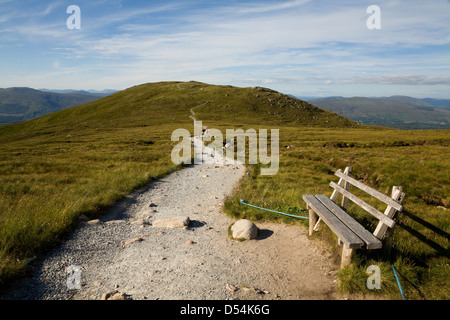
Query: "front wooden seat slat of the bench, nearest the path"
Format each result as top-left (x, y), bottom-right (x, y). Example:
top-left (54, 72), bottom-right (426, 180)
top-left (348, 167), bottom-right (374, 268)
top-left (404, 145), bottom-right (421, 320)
top-left (303, 195), bottom-right (364, 249)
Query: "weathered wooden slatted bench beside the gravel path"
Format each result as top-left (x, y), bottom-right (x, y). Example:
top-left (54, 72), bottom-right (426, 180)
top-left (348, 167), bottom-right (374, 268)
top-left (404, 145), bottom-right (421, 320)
top-left (303, 167), bottom-right (405, 267)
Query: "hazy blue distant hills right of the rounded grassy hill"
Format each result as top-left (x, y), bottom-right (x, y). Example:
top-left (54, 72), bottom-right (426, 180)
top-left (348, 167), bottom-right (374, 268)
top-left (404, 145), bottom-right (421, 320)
top-left (309, 96), bottom-right (450, 129)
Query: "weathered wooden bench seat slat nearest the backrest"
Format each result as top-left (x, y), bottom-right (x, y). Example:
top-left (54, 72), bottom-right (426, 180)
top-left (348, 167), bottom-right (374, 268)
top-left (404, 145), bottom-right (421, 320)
top-left (316, 194), bottom-right (383, 249)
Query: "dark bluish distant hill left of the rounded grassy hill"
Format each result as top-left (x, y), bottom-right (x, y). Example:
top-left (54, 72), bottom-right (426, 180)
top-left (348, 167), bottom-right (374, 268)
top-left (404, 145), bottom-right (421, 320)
top-left (0, 88), bottom-right (111, 124)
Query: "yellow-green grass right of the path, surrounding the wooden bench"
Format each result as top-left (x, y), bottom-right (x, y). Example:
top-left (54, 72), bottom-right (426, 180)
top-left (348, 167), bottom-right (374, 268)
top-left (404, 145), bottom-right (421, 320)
top-left (225, 127), bottom-right (450, 299)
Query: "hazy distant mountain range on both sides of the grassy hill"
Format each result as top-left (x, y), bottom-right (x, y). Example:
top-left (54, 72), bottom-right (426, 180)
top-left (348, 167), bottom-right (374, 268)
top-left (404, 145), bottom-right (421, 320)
top-left (0, 88), bottom-right (450, 129)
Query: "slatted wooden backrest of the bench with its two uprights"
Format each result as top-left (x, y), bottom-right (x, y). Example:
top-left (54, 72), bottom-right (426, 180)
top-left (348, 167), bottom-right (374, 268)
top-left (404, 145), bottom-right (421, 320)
top-left (330, 167), bottom-right (405, 239)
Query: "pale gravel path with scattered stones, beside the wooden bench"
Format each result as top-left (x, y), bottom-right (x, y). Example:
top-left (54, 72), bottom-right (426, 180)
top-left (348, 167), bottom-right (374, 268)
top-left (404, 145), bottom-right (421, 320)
top-left (1, 137), bottom-right (337, 300)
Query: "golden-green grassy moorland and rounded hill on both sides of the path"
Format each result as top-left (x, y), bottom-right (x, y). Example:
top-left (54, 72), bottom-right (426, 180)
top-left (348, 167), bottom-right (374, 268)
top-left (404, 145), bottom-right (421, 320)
top-left (0, 82), bottom-right (450, 299)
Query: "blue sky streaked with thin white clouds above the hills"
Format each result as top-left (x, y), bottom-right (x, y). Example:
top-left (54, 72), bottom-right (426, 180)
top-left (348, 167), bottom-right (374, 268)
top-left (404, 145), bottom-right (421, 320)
top-left (0, 0), bottom-right (450, 98)
